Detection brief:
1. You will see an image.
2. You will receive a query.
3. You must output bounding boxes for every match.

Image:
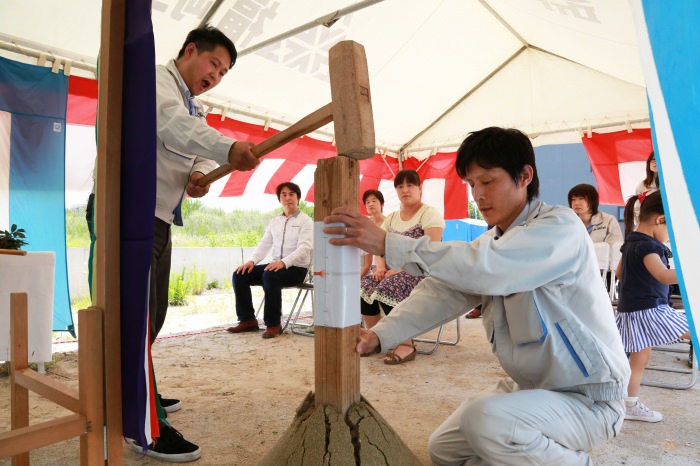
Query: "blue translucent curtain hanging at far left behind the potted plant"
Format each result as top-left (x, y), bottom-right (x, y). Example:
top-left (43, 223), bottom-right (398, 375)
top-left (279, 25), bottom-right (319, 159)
top-left (0, 57), bottom-right (73, 332)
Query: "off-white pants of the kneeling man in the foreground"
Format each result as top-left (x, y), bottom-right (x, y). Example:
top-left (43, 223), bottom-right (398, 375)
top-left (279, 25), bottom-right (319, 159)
top-left (428, 383), bottom-right (625, 466)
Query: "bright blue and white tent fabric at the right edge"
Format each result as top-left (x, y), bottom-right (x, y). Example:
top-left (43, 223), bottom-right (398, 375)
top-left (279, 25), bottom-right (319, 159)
top-left (630, 0), bottom-right (700, 348)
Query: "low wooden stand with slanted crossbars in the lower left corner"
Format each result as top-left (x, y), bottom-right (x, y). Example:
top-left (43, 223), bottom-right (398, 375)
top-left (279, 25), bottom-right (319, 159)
top-left (0, 293), bottom-right (104, 466)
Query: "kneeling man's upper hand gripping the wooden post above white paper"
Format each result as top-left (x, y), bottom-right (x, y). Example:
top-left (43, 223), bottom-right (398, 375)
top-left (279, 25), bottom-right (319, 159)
top-left (323, 207), bottom-right (386, 256)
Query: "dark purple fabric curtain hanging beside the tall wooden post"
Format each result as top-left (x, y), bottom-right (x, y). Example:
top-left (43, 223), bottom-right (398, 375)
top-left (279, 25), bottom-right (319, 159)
top-left (120, 0), bottom-right (157, 445)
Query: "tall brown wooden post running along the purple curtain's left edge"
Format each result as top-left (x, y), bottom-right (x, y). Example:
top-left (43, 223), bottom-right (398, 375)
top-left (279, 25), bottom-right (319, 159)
top-left (93, 0), bottom-right (126, 466)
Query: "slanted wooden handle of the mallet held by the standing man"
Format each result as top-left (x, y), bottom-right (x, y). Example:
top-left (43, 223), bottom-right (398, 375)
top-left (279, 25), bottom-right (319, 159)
top-left (199, 104), bottom-right (333, 186)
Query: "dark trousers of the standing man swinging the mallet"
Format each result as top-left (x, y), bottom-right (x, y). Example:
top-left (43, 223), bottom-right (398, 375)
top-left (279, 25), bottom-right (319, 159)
top-left (148, 218), bottom-right (173, 344)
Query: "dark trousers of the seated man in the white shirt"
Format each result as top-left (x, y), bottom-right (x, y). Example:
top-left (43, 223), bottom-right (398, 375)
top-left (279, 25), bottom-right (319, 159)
top-left (231, 264), bottom-right (307, 327)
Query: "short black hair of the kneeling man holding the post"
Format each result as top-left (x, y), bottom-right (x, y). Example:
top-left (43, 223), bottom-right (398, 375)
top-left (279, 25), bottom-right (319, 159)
top-left (455, 126), bottom-right (540, 201)
